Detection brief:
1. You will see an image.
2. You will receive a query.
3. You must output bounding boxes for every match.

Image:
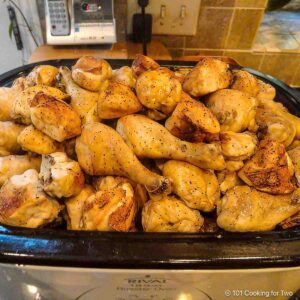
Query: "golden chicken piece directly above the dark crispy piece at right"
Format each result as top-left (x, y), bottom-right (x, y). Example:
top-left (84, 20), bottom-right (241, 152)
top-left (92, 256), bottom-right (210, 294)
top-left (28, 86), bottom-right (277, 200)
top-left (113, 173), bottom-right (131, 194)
top-left (255, 107), bottom-right (296, 147)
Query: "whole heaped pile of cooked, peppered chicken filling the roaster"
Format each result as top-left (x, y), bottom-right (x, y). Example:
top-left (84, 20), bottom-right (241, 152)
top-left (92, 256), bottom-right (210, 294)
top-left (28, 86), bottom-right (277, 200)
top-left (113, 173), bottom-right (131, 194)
top-left (0, 55), bottom-right (300, 232)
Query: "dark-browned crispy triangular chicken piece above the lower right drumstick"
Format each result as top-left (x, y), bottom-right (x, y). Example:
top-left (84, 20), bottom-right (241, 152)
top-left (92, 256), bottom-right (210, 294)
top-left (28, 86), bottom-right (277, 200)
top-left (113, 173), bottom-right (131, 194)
top-left (238, 139), bottom-right (295, 194)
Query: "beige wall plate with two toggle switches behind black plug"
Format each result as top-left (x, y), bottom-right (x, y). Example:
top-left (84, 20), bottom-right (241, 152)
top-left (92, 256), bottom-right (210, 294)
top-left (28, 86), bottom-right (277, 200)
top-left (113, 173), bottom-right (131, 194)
top-left (127, 0), bottom-right (200, 35)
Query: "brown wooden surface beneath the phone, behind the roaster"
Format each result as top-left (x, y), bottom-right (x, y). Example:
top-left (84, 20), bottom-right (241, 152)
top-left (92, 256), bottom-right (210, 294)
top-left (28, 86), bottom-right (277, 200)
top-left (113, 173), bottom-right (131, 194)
top-left (28, 40), bottom-right (172, 63)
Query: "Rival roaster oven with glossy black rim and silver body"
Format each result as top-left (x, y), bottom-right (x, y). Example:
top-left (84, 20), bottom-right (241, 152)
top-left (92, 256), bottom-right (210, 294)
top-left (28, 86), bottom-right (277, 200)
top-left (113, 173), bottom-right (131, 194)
top-left (0, 60), bottom-right (300, 300)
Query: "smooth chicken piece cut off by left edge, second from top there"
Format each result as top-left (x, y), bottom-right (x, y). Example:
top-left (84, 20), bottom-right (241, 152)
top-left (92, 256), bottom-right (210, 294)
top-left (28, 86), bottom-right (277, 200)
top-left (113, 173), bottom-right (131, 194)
top-left (0, 121), bottom-right (25, 156)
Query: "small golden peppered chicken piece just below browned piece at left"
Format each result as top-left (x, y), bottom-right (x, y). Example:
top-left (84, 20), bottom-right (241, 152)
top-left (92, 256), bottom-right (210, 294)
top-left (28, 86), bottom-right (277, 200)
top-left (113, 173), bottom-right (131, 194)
top-left (17, 125), bottom-right (63, 154)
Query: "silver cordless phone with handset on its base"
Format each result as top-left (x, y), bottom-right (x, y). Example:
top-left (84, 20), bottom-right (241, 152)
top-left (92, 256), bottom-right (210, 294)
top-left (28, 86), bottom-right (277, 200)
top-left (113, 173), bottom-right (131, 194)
top-left (45, 0), bottom-right (116, 45)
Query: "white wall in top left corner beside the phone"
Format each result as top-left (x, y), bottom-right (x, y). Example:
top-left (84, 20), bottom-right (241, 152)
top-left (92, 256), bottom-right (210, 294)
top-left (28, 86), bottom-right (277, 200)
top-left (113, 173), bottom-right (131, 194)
top-left (0, 0), bottom-right (43, 74)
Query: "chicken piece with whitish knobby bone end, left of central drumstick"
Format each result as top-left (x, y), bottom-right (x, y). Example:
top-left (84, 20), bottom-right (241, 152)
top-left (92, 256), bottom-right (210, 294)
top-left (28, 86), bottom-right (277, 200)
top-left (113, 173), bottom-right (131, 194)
top-left (40, 152), bottom-right (84, 198)
